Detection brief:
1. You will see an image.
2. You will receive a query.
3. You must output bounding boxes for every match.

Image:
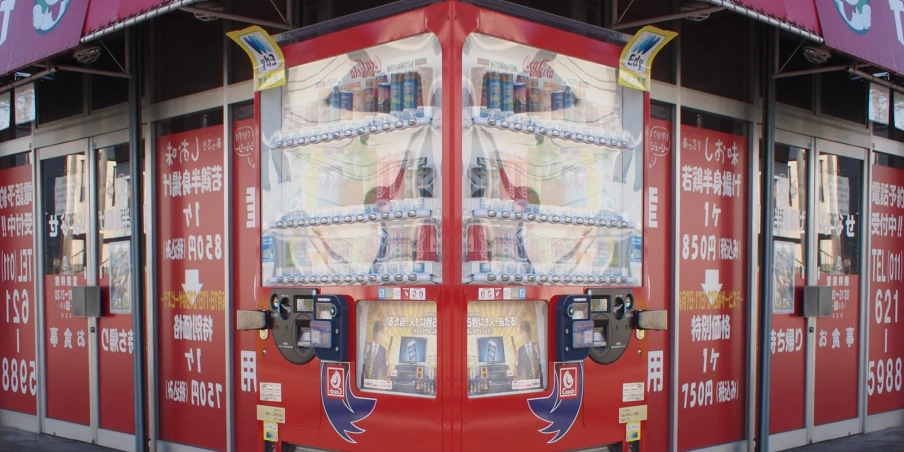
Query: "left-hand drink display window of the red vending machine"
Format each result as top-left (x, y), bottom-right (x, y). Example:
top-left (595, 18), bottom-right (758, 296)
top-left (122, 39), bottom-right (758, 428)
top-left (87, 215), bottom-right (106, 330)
top-left (261, 33), bottom-right (442, 286)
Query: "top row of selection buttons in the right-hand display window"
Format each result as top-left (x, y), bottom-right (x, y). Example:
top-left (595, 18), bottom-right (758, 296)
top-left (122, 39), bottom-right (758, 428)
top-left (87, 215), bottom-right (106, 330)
top-left (471, 112), bottom-right (639, 150)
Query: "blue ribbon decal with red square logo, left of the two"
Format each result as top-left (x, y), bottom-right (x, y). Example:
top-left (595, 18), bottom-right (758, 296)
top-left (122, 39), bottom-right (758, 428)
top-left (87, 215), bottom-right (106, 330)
top-left (320, 362), bottom-right (377, 443)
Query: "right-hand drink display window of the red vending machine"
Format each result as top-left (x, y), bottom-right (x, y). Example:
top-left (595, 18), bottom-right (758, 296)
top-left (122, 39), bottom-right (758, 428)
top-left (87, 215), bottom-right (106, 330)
top-left (462, 34), bottom-right (644, 286)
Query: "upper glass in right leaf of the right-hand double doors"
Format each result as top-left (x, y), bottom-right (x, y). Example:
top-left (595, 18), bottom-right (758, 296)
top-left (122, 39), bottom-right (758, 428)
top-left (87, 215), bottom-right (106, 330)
top-left (816, 154), bottom-right (863, 275)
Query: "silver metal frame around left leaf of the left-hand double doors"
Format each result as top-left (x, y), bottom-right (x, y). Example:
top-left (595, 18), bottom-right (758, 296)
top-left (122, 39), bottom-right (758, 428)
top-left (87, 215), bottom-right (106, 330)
top-left (34, 139), bottom-right (98, 443)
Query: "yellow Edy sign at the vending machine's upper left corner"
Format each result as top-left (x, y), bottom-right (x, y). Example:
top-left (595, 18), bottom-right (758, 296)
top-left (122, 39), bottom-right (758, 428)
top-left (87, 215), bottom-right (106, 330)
top-left (226, 25), bottom-right (286, 91)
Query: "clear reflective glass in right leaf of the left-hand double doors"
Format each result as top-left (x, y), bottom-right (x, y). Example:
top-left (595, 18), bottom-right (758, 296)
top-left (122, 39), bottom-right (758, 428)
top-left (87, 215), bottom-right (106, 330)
top-left (97, 144), bottom-right (132, 314)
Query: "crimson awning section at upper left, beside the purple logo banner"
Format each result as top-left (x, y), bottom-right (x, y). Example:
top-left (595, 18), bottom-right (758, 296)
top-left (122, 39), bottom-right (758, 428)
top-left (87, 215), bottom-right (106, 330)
top-left (81, 0), bottom-right (199, 43)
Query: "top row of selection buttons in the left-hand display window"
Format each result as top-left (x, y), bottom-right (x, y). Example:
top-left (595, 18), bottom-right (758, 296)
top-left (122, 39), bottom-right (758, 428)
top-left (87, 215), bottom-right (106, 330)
top-left (270, 110), bottom-right (433, 150)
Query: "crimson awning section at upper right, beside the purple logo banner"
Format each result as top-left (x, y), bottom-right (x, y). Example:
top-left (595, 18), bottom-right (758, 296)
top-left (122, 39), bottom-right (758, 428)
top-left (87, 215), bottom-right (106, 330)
top-left (706, 0), bottom-right (834, 43)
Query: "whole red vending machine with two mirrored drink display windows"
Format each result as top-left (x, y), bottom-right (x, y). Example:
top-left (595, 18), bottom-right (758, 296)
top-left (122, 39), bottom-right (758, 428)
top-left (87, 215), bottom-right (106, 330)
top-left (244, 1), bottom-right (665, 451)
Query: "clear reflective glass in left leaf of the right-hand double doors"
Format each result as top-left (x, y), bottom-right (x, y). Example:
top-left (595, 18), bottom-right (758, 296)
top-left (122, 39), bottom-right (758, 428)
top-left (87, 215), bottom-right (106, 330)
top-left (772, 144), bottom-right (807, 313)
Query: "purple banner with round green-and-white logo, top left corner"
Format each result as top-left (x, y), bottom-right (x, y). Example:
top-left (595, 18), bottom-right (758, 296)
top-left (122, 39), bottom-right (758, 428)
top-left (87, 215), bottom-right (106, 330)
top-left (0, 0), bottom-right (88, 73)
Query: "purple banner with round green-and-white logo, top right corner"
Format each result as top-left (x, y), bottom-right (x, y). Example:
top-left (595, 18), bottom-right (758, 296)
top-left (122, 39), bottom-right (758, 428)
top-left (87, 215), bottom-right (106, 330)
top-left (816, 0), bottom-right (904, 74)
